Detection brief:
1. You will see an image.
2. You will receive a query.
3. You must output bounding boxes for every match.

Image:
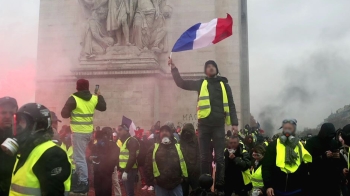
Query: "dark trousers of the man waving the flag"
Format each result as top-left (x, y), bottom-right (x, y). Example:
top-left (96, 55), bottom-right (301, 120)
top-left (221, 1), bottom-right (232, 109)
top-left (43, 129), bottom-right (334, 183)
top-left (198, 124), bottom-right (225, 189)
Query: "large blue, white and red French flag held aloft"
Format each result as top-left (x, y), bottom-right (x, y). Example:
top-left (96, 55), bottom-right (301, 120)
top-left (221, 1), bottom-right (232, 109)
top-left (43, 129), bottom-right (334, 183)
top-left (171, 14), bottom-right (233, 52)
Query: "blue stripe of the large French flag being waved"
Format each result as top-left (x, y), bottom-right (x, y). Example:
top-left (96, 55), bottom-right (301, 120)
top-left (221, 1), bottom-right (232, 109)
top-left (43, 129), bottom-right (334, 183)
top-left (172, 23), bottom-right (201, 52)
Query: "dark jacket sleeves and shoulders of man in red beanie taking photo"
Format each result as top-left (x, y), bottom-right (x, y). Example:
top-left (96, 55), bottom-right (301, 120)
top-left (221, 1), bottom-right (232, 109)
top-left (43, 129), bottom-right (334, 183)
top-left (61, 90), bottom-right (107, 118)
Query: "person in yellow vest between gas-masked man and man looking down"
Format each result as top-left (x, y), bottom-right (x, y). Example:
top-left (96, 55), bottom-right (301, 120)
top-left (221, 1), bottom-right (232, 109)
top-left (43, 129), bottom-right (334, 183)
top-left (251, 145), bottom-right (266, 196)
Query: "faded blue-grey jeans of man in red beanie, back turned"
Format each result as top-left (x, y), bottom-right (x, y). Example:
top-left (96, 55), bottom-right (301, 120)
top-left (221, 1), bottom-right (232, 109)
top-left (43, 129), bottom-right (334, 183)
top-left (72, 133), bottom-right (92, 184)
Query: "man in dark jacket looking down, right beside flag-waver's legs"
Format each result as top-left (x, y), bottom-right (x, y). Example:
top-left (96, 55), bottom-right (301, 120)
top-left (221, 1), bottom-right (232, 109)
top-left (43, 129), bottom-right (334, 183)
top-left (224, 136), bottom-right (252, 196)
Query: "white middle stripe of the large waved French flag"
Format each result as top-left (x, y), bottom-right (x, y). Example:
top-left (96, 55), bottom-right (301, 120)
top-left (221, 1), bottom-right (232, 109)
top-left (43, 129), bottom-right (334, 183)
top-left (193, 18), bottom-right (218, 50)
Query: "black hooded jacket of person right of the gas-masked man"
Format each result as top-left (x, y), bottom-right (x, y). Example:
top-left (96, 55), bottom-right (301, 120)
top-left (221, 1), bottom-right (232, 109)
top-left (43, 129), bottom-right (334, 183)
top-left (305, 123), bottom-right (343, 195)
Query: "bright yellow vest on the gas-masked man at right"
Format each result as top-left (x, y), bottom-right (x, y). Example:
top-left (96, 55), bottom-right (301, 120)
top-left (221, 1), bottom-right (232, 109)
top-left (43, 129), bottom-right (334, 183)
top-left (276, 138), bottom-right (312, 174)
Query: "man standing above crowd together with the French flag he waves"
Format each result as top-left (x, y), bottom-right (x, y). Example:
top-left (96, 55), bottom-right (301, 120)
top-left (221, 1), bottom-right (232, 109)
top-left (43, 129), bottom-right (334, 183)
top-left (168, 14), bottom-right (238, 195)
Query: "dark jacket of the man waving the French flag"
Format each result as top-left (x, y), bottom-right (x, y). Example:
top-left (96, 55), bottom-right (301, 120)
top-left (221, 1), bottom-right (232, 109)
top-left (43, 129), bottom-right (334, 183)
top-left (171, 68), bottom-right (238, 126)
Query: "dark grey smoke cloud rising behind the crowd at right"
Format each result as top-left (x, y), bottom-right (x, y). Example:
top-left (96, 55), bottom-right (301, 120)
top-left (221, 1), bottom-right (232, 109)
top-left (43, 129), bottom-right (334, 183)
top-left (258, 49), bottom-right (350, 135)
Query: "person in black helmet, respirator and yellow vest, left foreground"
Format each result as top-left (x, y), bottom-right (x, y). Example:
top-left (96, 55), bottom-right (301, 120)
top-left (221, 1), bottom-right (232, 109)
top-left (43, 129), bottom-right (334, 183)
top-left (1, 103), bottom-right (71, 196)
